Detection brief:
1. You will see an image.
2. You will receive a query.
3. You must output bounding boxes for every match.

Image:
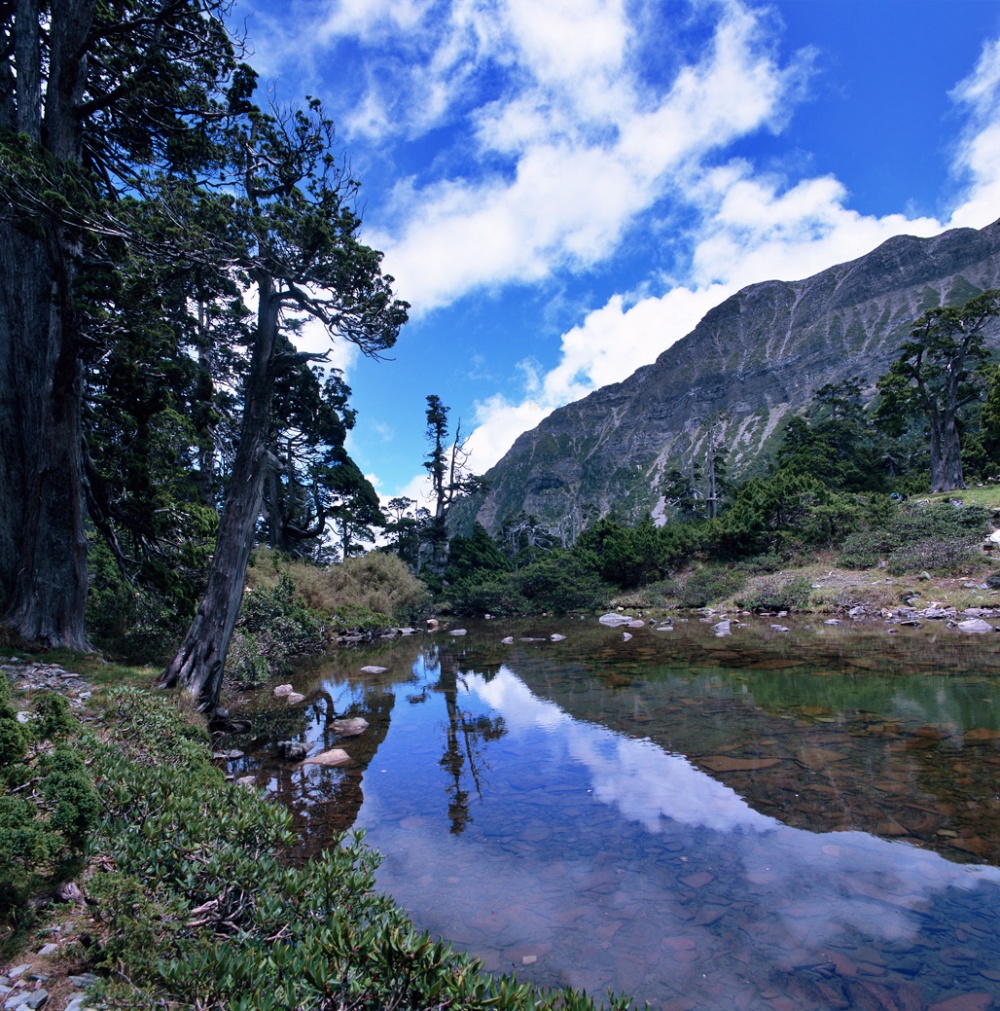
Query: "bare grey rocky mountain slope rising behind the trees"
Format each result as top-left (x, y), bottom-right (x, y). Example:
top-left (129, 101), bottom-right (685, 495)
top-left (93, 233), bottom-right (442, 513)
top-left (470, 221), bottom-right (1000, 540)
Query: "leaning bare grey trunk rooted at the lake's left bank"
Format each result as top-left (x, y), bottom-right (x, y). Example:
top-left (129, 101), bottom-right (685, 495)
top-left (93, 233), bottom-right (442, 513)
top-left (160, 273), bottom-right (280, 712)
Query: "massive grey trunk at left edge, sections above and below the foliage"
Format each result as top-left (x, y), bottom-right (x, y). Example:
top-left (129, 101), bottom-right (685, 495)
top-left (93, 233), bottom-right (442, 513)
top-left (0, 0), bottom-right (94, 650)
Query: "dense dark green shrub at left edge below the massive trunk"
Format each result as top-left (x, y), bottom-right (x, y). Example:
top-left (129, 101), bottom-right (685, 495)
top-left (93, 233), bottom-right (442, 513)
top-left (0, 674), bottom-right (100, 923)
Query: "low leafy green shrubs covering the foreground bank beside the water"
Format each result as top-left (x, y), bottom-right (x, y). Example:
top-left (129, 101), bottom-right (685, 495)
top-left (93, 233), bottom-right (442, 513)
top-left (90, 690), bottom-right (629, 1011)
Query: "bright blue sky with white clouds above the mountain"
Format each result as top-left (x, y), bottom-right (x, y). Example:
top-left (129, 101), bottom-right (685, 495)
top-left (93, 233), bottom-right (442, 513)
top-left (234, 0), bottom-right (1000, 505)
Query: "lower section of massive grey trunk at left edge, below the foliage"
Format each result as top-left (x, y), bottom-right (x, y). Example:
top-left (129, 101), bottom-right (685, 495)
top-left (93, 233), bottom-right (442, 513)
top-left (0, 223), bottom-right (91, 650)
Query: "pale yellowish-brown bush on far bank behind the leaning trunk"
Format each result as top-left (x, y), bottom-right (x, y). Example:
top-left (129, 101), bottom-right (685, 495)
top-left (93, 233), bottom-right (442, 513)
top-left (247, 549), bottom-right (431, 622)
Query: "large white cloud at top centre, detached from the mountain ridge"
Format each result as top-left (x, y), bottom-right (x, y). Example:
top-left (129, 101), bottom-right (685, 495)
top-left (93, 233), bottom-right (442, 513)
top-left (368, 2), bottom-right (803, 314)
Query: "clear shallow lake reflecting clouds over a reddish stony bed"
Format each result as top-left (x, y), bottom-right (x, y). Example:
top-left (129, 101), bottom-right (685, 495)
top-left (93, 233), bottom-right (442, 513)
top-left (224, 615), bottom-right (1000, 1011)
